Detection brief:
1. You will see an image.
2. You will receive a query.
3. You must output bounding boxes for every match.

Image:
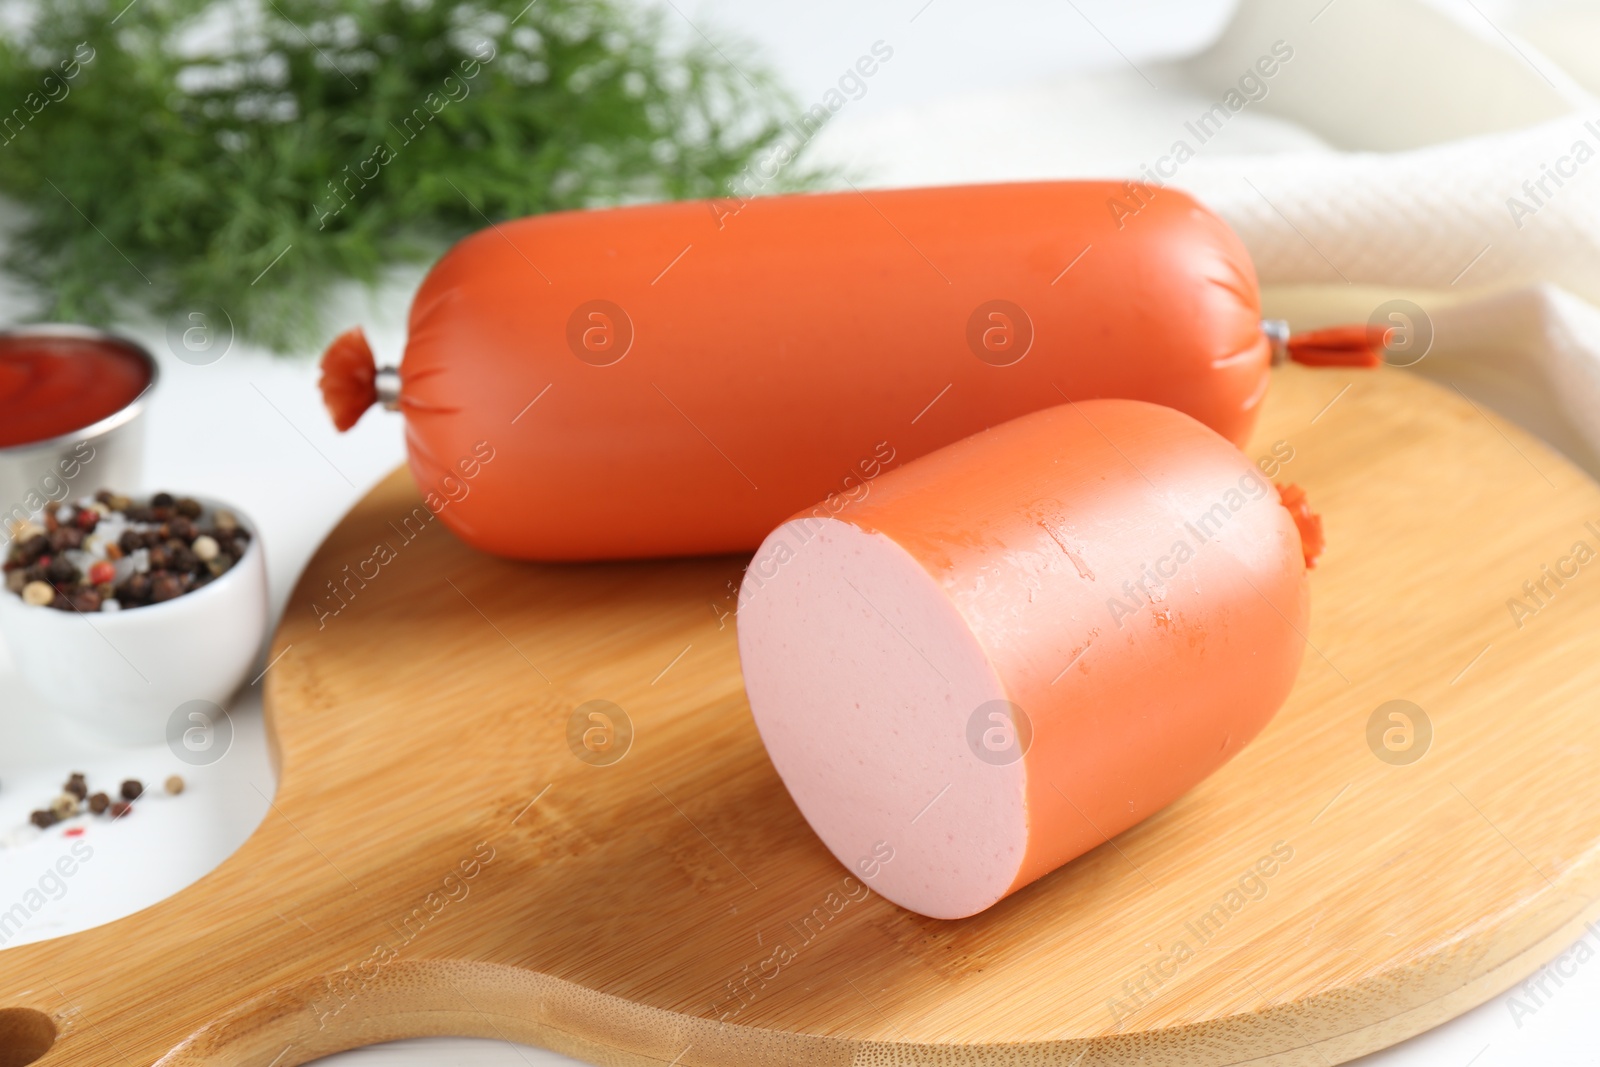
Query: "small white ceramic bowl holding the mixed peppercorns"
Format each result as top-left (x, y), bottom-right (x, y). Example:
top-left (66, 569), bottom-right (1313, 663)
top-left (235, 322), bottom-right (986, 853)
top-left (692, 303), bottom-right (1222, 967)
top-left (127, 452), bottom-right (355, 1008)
top-left (0, 498), bottom-right (267, 744)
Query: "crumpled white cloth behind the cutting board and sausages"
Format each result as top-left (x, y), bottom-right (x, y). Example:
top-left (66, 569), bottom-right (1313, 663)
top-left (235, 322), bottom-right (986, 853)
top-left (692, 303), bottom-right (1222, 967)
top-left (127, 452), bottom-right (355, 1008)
top-left (818, 0), bottom-right (1600, 477)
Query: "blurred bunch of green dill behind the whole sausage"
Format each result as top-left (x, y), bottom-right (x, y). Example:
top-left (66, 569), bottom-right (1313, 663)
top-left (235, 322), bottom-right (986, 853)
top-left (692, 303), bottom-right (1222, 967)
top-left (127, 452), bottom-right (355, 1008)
top-left (0, 0), bottom-right (814, 350)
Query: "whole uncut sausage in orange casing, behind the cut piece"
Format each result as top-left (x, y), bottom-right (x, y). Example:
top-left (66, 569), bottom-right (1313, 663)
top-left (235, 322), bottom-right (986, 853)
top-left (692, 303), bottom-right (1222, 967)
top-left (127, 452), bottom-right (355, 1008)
top-left (325, 182), bottom-right (1270, 560)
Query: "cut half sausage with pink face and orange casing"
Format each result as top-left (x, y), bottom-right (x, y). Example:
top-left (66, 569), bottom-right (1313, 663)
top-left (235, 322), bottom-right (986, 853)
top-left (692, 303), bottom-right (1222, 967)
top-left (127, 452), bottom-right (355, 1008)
top-left (738, 400), bottom-right (1309, 918)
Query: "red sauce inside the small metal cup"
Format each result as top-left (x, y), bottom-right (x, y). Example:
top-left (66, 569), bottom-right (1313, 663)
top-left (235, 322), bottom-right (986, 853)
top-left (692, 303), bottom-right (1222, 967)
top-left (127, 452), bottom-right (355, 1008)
top-left (0, 336), bottom-right (150, 448)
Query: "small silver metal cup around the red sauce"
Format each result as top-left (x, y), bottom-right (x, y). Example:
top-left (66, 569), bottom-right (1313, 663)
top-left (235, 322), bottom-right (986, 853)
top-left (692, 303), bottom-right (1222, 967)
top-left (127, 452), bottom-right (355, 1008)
top-left (0, 323), bottom-right (160, 552)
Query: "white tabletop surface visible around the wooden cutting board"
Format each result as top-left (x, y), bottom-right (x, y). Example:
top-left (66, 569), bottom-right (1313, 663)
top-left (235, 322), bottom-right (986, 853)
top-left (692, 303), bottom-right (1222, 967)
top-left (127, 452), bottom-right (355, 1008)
top-left (0, 0), bottom-right (1600, 1067)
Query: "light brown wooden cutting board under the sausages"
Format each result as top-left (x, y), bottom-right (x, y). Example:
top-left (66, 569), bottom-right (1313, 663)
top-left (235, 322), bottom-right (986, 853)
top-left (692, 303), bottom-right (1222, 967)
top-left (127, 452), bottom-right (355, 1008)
top-left (0, 368), bottom-right (1600, 1067)
